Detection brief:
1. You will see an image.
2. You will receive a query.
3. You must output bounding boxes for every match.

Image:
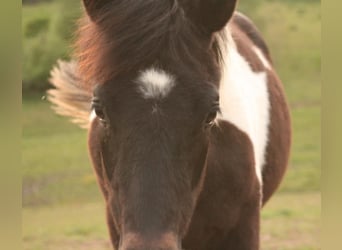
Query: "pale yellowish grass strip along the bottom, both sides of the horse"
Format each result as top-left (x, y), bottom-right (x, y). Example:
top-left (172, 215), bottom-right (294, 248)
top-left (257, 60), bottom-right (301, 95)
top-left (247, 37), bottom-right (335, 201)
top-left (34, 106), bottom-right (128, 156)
top-left (23, 193), bottom-right (321, 250)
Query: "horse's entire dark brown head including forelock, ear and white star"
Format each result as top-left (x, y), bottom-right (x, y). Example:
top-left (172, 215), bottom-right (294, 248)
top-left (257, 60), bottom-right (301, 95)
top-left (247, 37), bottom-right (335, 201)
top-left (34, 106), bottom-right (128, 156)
top-left (82, 0), bottom-right (236, 250)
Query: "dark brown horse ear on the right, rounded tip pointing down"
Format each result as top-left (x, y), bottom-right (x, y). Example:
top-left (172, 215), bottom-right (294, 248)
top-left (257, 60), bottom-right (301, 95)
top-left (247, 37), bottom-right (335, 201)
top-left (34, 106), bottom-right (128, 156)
top-left (180, 0), bottom-right (237, 34)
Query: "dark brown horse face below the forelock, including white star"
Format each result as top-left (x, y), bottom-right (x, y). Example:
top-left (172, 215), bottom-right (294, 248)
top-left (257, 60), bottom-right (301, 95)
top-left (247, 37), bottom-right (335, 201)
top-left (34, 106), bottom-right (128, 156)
top-left (90, 73), bottom-right (218, 249)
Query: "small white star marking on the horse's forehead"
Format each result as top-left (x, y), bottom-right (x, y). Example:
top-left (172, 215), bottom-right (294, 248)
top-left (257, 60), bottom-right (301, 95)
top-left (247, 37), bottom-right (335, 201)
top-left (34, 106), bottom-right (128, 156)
top-left (137, 68), bottom-right (175, 99)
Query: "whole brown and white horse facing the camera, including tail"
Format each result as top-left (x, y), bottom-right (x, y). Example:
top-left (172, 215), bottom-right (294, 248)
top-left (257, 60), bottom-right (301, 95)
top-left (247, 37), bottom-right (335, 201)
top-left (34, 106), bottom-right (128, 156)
top-left (48, 0), bottom-right (291, 250)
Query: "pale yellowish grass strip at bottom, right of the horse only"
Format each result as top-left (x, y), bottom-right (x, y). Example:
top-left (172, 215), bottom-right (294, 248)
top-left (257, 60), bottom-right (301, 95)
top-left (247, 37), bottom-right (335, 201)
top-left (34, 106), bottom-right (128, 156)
top-left (261, 193), bottom-right (321, 250)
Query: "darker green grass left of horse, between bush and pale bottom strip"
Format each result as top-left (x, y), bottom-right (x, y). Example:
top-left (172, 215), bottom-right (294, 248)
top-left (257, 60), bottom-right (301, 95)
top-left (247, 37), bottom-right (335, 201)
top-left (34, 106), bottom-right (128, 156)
top-left (22, 98), bottom-right (99, 206)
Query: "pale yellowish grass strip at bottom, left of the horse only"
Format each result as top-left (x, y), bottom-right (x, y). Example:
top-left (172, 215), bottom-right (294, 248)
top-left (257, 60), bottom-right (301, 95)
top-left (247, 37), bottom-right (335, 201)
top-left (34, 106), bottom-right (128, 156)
top-left (22, 202), bottom-right (110, 250)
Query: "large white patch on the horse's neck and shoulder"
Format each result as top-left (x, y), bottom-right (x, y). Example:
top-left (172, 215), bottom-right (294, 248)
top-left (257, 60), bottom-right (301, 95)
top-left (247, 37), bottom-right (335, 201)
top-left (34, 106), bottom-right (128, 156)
top-left (218, 28), bottom-right (270, 184)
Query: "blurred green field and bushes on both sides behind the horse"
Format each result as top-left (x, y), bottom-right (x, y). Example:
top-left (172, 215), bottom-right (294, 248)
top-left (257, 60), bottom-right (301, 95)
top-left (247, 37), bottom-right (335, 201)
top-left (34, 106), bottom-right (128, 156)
top-left (22, 0), bottom-right (321, 250)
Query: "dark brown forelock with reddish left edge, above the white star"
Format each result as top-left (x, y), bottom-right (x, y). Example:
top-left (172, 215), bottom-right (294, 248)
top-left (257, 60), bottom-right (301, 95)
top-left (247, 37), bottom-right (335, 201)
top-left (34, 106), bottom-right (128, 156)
top-left (75, 0), bottom-right (224, 87)
